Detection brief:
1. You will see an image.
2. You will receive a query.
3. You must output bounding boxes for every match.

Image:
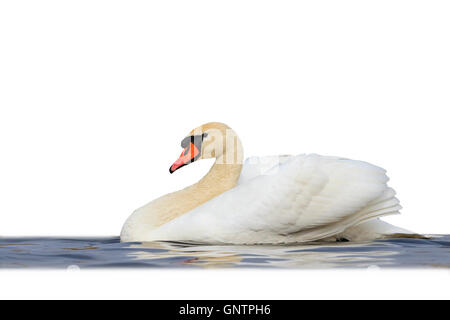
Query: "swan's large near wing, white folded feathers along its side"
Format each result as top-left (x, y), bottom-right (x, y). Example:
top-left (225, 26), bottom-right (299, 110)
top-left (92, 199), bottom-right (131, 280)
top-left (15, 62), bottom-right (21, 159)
top-left (151, 155), bottom-right (400, 243)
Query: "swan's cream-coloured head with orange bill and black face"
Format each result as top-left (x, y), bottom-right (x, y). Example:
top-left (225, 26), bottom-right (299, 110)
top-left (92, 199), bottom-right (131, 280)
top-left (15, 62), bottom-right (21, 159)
top-left (169, 122), bottom-right (242, 173)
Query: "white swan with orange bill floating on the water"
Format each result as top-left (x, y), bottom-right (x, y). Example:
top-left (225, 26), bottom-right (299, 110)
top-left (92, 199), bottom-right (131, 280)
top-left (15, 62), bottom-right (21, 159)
top-left (120, 122), bottom-right (415, 244)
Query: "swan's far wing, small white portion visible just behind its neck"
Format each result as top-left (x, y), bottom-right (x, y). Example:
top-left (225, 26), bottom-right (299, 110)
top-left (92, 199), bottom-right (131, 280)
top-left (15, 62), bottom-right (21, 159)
top-left (238, 155), bottom-right (292, 185)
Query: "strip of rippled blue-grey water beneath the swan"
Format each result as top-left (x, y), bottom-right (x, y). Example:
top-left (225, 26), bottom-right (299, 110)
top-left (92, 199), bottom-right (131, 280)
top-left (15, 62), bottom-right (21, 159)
top-left (0, 235), bottom-right (450, 270)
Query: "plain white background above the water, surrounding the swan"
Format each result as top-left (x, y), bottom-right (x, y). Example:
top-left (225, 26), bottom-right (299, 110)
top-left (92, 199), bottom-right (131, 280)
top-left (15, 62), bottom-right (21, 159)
top-left (0, 0), bottom-right (450, 297)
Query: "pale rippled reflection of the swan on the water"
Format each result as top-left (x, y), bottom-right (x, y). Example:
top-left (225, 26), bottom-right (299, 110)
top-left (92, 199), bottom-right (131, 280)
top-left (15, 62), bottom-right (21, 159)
top-left (124, 242), bottom-right (396, 268)
